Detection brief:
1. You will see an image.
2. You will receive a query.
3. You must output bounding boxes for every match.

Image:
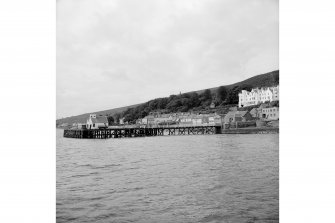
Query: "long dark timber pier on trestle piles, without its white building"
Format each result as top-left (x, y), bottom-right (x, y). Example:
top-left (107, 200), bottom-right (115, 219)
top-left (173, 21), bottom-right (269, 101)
top-left (64, 125), bottom-right (221, 139)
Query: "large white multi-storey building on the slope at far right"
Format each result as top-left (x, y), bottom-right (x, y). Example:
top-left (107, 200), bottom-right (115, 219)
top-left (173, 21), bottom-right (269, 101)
top-left (238, 85), bottom-right (279, 107)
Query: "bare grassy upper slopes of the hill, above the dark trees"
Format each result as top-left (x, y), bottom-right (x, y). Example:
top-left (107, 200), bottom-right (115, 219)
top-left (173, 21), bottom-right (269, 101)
top-left (56, 70), bottom-right (279, 125)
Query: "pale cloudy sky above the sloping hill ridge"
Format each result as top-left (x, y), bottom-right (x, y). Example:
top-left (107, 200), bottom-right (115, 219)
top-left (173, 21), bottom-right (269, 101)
top-left (56, 0), bottom-right (279, 118)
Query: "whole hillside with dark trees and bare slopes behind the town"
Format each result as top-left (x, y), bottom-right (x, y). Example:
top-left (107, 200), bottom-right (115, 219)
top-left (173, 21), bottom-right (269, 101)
top-left (56, 70), bottom-right (279, 125)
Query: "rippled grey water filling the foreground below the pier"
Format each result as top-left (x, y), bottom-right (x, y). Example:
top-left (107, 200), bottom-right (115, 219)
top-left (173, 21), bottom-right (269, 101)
top-left (57, 130), bottom-right (279, 223)
